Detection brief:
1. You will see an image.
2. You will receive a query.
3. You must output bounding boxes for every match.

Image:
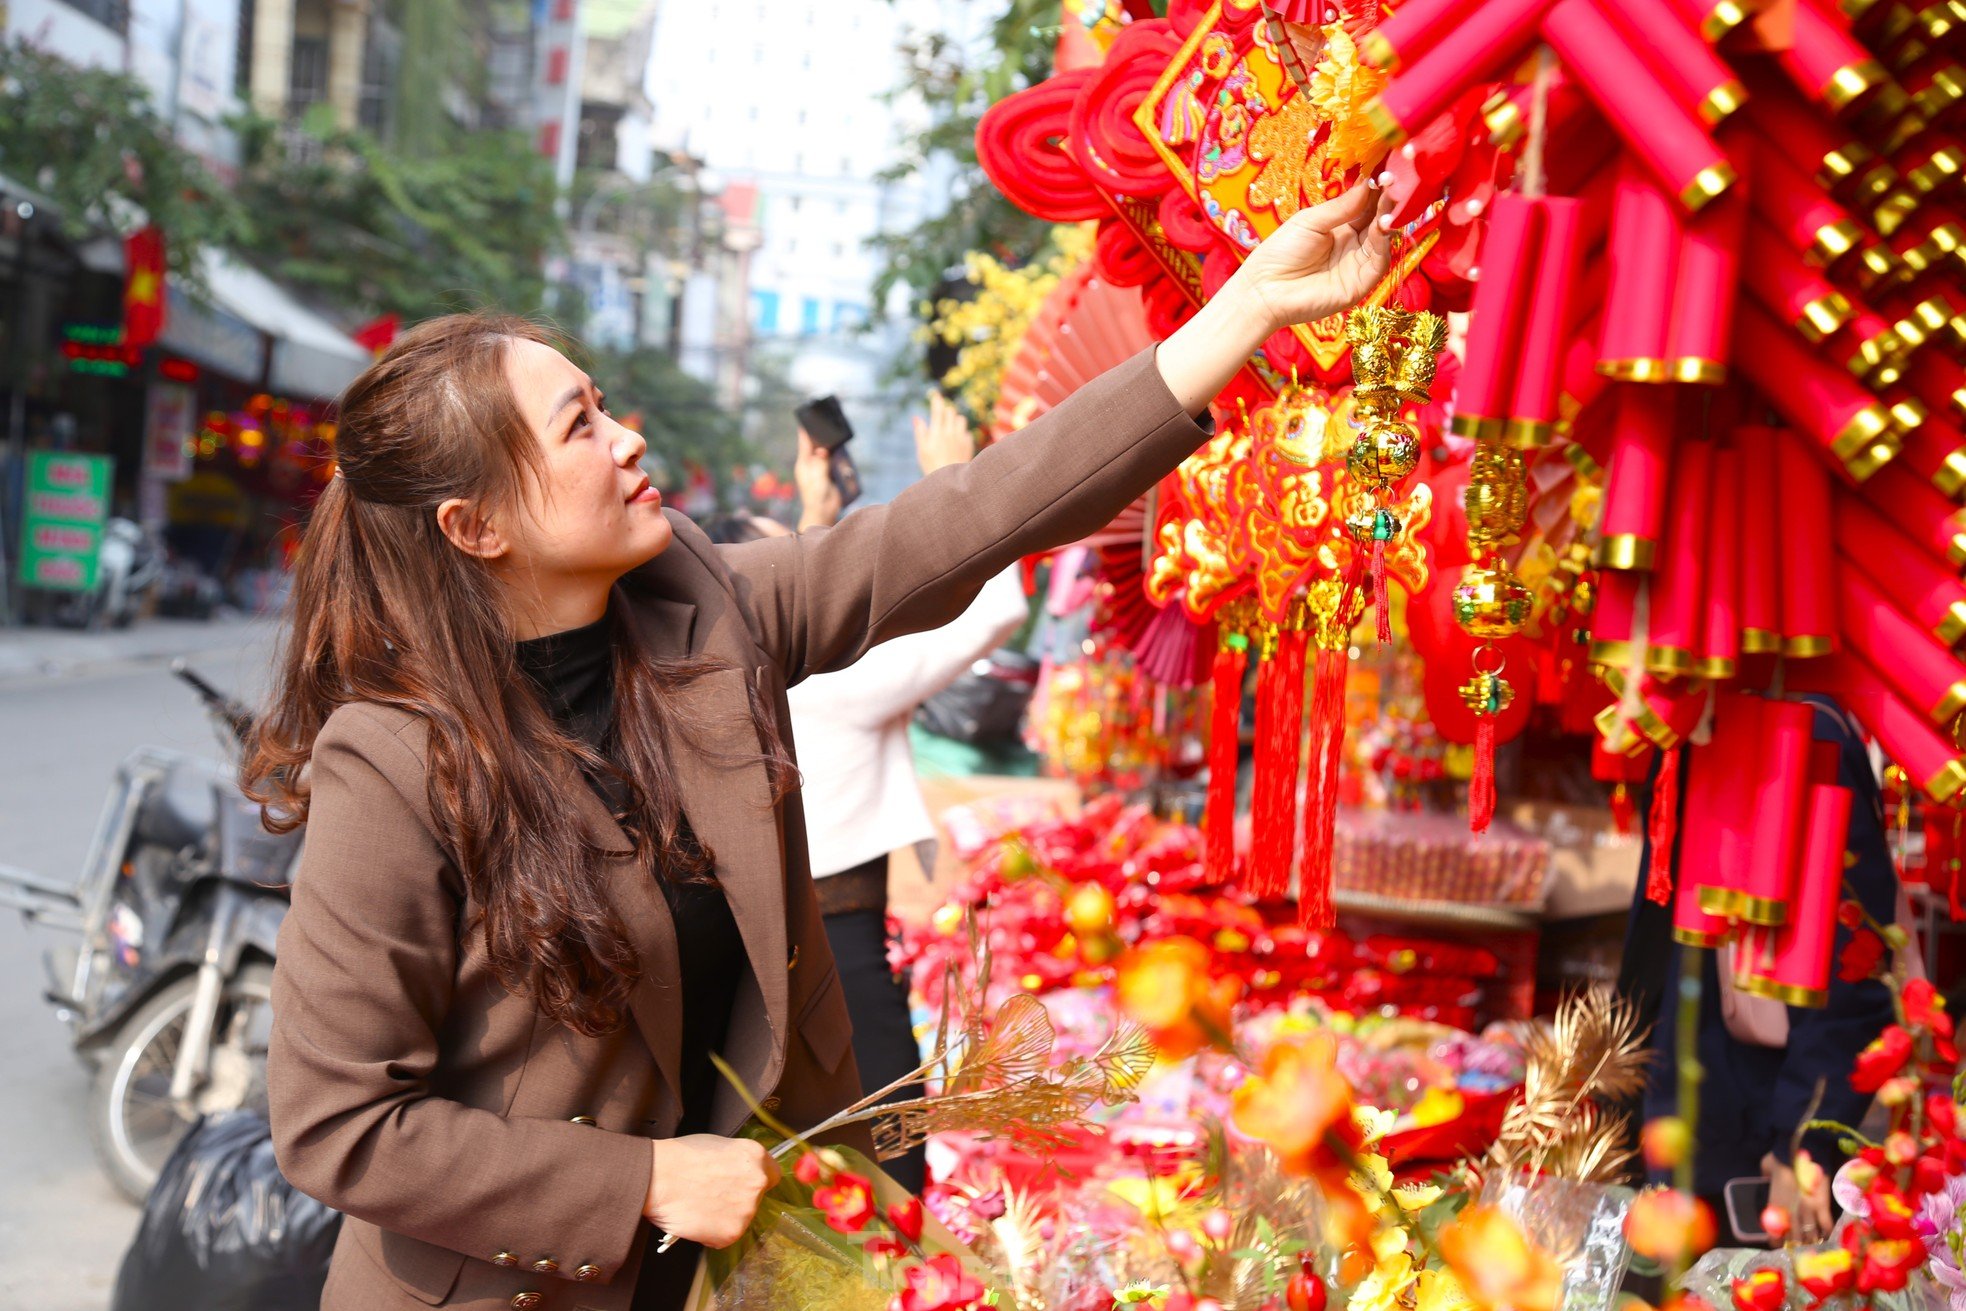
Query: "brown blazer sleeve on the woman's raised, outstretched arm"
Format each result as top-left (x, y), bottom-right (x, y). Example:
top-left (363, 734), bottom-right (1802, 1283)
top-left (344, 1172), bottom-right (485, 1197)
top-left (720, 348), bottom-right (1207, 684)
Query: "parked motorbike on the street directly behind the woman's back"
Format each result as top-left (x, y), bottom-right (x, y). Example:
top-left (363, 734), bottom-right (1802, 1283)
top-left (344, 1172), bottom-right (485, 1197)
top-left (0, 660), bottom-right (301, 1201)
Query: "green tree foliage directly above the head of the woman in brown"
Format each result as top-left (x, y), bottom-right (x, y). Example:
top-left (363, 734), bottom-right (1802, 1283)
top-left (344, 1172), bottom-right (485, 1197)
top-left (238, 112), bottom-right (564, 318)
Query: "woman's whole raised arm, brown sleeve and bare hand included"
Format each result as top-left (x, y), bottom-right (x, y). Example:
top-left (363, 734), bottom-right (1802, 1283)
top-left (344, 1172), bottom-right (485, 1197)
top-left (722, 185), bottom-right (1388, 682)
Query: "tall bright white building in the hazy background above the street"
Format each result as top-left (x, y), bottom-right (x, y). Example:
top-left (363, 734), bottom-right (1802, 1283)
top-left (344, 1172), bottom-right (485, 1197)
top-left (647, 0), bottom-right (975, 501)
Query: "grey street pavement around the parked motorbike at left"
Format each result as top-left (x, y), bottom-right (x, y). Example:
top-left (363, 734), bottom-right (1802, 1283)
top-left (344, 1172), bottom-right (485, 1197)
top-left (0, 619), bottom-right (273, 1311)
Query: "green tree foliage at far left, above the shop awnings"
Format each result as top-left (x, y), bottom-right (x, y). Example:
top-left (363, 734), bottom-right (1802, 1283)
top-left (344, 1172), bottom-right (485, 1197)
top-left (0, 41), bottom-right (244, 275)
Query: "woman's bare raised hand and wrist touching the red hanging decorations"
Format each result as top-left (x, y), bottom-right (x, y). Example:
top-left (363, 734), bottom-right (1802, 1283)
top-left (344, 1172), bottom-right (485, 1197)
top-left (1156, 181), bottom-right (1392, 415)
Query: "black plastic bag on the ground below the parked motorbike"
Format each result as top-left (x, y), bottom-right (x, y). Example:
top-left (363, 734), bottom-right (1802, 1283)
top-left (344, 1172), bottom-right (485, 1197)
top-left (110, 1111), bottom-right (342, 1311)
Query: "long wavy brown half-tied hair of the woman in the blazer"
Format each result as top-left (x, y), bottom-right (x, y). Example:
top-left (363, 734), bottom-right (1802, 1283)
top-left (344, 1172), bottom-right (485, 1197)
top-left (242, 314), bottom-right (792, 1034)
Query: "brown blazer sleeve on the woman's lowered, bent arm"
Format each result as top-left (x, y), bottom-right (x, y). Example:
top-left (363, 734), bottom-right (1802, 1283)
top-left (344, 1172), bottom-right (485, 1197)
top-left (267, 710), bottom-right (651, 1280)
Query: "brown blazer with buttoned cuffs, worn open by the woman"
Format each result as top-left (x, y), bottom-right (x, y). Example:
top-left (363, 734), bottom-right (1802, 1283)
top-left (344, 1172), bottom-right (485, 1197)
top-left (267, 352), bottom-right (1205, 1311)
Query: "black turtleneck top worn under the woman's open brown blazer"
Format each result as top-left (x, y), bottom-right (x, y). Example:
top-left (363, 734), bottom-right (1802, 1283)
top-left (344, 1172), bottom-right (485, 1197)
top-left (515, 615), bottom-right (747, 1136)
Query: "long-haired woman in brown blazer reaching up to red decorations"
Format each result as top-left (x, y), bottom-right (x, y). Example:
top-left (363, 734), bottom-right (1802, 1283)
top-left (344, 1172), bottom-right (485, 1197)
top-left (257, 187), bottom-right (1388, 1311)
